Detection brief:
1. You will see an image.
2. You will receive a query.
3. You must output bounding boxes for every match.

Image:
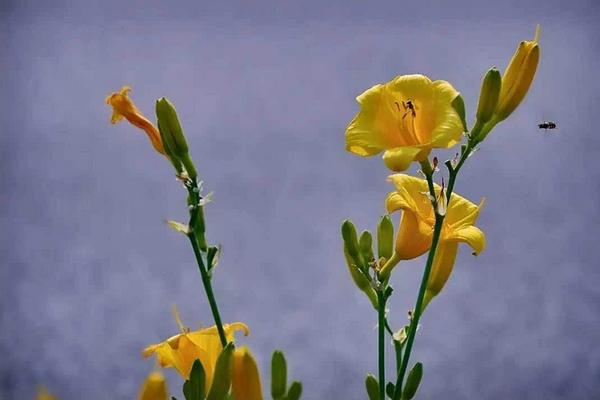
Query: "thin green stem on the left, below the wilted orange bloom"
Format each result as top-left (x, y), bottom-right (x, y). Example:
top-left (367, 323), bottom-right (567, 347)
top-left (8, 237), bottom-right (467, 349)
top-left (186, 180), bottom-right (227, 347)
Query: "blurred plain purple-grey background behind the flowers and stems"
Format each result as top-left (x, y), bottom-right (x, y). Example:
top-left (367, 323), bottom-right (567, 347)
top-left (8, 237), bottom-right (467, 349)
top-left (0, 0), bottom-right (600, 400)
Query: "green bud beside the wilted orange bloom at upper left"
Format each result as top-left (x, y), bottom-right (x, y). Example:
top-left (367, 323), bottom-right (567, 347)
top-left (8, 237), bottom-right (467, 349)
top-left (156, 97), bottom-right (198, 179)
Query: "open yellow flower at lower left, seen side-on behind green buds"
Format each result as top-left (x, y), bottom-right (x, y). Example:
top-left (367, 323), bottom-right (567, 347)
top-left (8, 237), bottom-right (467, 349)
top-left (142, 312), bottom-right (250, 388)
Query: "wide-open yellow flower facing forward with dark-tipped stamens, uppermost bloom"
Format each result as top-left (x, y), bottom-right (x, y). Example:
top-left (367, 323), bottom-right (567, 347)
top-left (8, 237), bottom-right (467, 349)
top-left (346, 75), bottom-right (463, 171)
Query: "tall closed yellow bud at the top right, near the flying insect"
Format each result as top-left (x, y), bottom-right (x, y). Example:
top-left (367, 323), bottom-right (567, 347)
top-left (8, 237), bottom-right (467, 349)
top-left (494, 25), bottom-right (540, 122)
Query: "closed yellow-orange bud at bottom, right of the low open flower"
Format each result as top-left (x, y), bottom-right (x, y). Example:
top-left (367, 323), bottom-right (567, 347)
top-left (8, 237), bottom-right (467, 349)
top-left (231, 347), bottom-right (263, 400)
